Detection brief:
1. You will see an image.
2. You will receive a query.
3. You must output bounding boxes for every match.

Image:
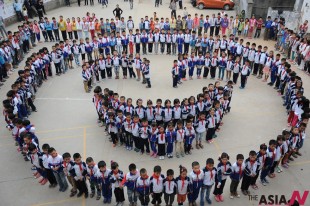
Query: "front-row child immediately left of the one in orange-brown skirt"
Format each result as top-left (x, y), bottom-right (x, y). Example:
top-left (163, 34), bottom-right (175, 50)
top-left (163, 169), bottom-right (177, 206)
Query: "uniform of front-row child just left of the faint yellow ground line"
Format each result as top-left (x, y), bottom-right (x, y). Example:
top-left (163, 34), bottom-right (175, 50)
top-left (72, 162), bottom-right (88, 196)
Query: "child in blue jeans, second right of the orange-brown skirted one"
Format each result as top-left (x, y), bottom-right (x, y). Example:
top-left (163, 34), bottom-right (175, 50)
top-left (200, 158), bottom-right (217, 206)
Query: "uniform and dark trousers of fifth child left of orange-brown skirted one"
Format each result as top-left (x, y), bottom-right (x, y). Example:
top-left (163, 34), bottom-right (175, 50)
top-left (109, 170), bottom-right (125, 203)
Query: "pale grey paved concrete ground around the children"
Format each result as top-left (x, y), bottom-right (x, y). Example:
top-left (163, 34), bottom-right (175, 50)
top-left (0, 0), bottom-right (310, 206)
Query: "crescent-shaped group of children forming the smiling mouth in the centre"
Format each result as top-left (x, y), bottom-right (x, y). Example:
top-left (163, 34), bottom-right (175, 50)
top-left (93, 81), bottom-right (233, 159)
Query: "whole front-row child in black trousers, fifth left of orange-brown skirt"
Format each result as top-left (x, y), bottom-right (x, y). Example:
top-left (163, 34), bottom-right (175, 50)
top-left (109, 161), bottom-right (125, 206)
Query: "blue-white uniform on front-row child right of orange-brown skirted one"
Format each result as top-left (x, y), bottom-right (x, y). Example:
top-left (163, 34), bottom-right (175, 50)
top-left (187, 170), bottom-right (204, 203)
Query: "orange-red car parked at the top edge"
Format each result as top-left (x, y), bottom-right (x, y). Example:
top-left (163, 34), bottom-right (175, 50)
top-left (191, 0), bottom-right (235, 10)
